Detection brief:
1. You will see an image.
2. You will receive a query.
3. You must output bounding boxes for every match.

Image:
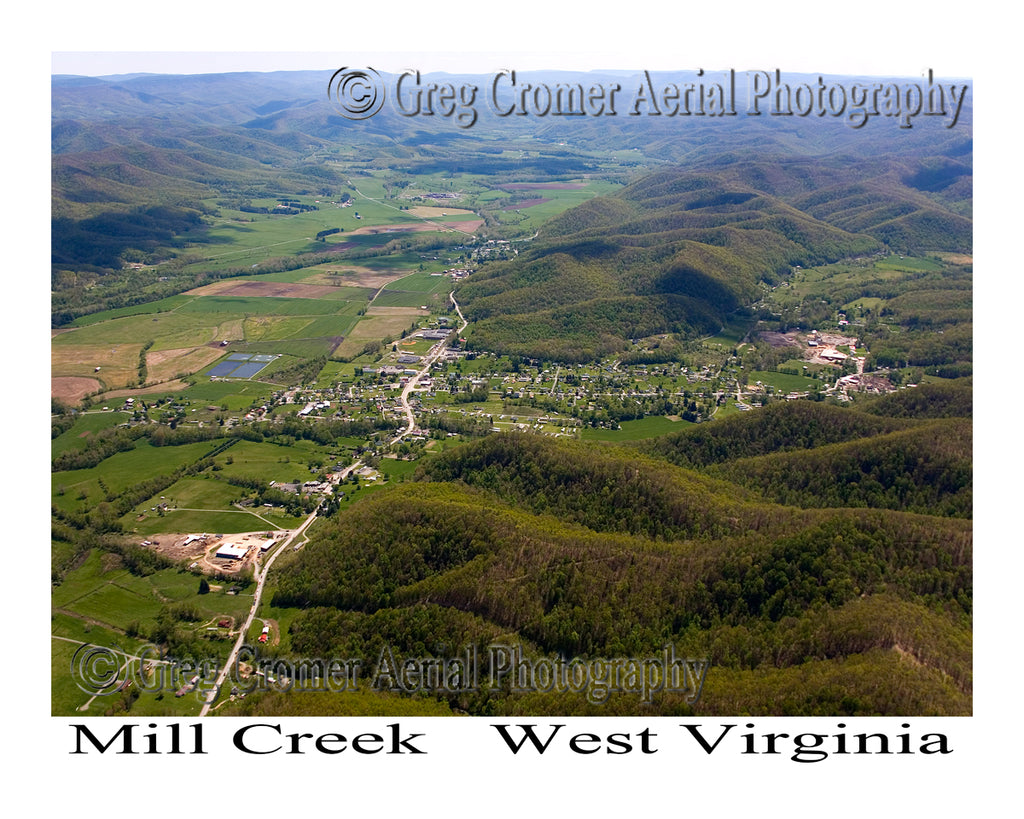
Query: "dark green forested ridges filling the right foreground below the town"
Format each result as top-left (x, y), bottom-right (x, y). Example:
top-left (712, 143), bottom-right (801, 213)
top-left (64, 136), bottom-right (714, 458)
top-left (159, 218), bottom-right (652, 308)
top-left (274, 391), bottom-right (972, 714)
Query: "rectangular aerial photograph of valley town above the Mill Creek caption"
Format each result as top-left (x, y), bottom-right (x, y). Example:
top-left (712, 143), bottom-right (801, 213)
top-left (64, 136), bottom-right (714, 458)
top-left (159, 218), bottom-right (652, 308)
top-left (50, 58), bottom-right (974, 724)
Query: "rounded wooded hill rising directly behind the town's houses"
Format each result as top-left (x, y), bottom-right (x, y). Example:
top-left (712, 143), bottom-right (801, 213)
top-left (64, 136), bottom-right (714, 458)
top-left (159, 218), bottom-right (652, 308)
top-left (458, 164), bottom-right (882, 361)
